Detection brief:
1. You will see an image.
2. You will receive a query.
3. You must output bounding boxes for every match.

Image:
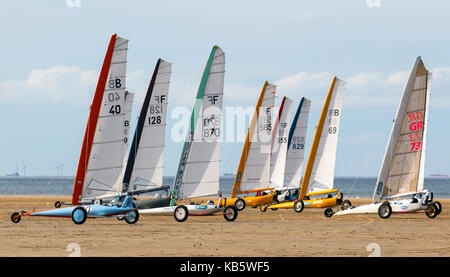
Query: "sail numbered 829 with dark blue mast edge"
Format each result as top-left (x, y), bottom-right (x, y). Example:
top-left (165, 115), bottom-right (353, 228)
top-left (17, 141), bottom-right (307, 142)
top-left (284, 98), bottom-right (311, 187)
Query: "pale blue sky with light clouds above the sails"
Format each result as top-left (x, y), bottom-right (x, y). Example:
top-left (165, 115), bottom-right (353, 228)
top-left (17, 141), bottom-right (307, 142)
top-left (0, 0), bottom-right (450, 176)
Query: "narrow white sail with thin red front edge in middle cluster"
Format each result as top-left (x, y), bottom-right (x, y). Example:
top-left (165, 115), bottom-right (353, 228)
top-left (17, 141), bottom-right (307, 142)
top-left (270, 97), bottom-right (292, 189)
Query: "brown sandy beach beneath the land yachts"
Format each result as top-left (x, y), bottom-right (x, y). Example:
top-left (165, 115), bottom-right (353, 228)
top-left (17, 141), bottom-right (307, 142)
top-left (0, 196), bottom-right (450, 257)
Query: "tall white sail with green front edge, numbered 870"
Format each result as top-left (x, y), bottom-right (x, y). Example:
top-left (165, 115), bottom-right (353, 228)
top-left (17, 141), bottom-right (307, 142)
top-left (170, 46), bottom-right (225, 206)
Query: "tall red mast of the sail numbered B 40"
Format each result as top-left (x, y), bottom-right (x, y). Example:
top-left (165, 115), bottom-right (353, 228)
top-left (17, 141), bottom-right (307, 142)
top-left (72, 34), bottom-right (117, 205)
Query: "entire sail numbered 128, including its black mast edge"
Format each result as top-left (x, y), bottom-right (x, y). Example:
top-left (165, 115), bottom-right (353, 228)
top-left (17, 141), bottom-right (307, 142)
top-left (123, 59), bottom-right (172, 192)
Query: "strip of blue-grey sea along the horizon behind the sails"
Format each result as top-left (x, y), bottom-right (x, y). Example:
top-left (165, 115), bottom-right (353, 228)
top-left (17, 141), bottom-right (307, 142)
top-left (0, 176), bottom-right (450, 198)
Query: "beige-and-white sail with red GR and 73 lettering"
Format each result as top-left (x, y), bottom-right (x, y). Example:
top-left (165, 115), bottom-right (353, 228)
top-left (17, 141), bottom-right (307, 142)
top-left (373, 57), bottom-right (431, 203)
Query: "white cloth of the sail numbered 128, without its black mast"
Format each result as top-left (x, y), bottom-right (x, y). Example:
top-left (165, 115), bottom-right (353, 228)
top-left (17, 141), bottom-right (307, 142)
top-left (128, 60), bottom-right (172, 192)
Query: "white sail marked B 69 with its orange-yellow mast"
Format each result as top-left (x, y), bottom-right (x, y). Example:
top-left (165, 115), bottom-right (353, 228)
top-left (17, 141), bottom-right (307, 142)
top-left (299, 77), bottom-right (345, 199)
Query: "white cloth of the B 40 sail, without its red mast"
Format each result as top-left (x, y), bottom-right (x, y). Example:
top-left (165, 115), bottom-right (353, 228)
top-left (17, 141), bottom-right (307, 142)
top-left (81, 37), bottom-right (129, 201)
